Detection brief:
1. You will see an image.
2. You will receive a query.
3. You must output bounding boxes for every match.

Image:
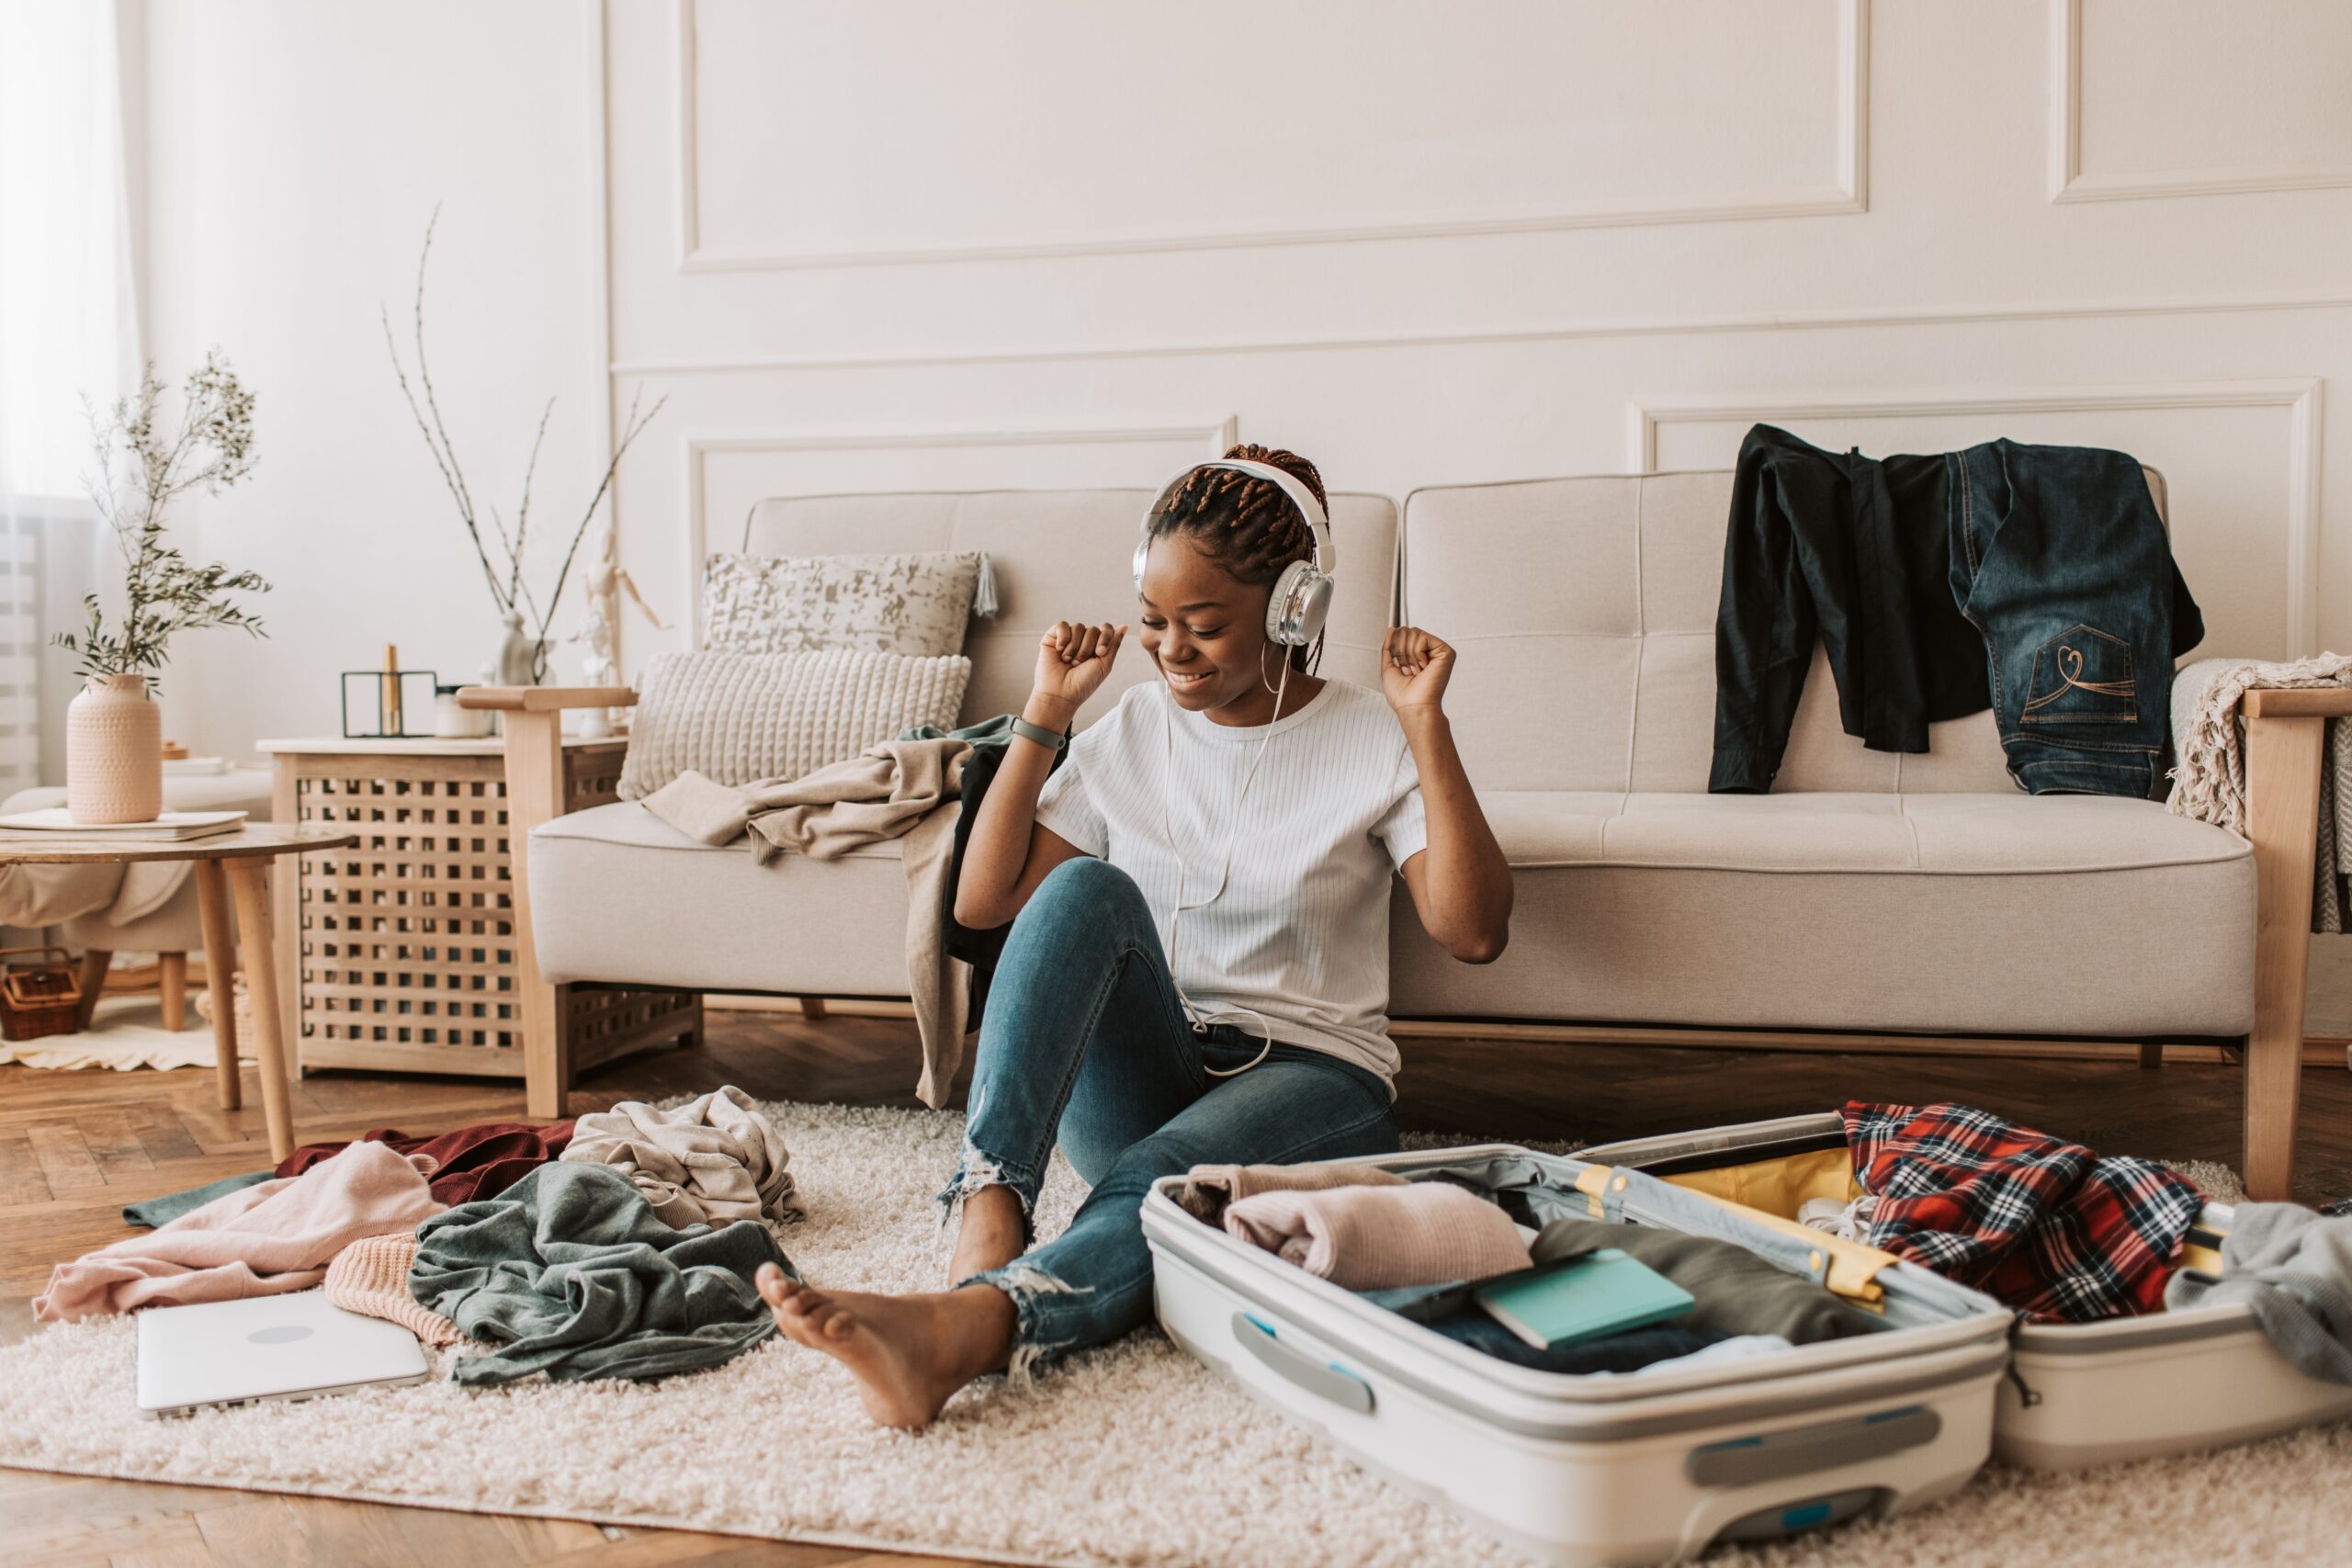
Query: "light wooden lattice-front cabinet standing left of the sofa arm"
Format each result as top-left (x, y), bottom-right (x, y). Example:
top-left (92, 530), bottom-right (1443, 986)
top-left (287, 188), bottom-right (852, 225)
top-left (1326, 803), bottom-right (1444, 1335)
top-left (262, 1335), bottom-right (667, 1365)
top-left (261, 739), bottom-right (701, 1117)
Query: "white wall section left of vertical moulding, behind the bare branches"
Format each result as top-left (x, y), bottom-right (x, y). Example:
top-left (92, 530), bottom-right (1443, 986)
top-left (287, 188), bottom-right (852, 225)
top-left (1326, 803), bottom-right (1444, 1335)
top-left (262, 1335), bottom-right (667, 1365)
top-left (146, 0), bottom-right (605, 755)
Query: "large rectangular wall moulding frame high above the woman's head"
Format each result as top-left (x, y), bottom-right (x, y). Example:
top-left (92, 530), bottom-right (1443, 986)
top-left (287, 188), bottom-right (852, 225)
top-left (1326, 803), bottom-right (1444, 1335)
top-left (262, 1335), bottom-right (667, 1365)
top-left (671, 0), bottom-right (1870, 273)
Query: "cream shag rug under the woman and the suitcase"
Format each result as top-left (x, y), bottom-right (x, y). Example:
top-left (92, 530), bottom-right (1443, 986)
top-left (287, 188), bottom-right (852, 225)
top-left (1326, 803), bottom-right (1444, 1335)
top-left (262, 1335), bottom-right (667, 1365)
top-left (0, 1105), bottom-right (2352, 1568)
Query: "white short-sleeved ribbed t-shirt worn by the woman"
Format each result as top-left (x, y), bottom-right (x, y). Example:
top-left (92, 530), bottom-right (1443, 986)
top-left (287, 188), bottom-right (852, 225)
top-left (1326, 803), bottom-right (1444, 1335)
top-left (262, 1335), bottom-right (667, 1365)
top-left (1037, 680), bottom-right (1428, 1079)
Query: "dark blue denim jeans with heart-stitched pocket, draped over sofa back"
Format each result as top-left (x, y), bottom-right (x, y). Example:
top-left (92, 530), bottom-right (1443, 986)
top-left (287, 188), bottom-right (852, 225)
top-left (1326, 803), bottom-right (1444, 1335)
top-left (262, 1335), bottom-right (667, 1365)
top-left (1945, 442), bottom-right (2204, 799)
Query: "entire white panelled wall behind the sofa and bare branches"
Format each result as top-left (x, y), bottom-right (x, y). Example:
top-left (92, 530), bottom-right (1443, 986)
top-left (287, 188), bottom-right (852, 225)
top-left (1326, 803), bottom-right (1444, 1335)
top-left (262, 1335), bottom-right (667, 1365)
top-left (137, 0), bottom-right (2352, 1029)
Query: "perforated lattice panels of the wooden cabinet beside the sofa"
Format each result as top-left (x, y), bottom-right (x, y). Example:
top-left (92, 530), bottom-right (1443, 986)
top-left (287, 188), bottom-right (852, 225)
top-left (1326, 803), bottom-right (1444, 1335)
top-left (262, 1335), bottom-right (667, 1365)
top-left (277, 740), bottom-right (701, 1079)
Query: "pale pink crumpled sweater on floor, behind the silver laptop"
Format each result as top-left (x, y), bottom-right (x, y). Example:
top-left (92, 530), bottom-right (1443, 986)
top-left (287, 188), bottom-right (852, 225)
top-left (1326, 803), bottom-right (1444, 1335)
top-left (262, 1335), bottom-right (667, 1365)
top-left (33, 1143), bottom-right (442, 1324)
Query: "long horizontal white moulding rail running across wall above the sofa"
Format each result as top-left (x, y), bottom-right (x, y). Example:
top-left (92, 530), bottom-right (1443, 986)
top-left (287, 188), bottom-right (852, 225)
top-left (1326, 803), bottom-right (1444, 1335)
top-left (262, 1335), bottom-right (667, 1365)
top-left (612, 291), bottom-right (2352, 376)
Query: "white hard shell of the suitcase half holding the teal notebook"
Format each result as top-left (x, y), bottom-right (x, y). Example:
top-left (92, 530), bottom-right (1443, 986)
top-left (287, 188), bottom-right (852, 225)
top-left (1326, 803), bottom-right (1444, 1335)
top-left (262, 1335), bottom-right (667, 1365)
top-left (1143, 1145), bottom-right (2008, 1563)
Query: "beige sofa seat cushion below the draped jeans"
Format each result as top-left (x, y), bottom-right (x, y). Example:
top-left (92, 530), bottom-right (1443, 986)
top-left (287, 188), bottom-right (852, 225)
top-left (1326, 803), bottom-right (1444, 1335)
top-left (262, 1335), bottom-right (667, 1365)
top-left (1390, 792), bottom-right (2253, 1043)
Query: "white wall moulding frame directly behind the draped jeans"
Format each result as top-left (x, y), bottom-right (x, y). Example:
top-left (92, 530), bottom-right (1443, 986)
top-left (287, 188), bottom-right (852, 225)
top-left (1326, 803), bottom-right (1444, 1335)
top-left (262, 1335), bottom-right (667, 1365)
top-left (1625, 376), bottom-right (2324, 659)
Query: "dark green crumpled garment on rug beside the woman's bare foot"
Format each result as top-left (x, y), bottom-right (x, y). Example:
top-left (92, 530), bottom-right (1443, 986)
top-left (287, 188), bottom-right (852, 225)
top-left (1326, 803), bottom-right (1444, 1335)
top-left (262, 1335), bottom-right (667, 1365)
top-left (409, 1161), bottom-right (799, 1387)
